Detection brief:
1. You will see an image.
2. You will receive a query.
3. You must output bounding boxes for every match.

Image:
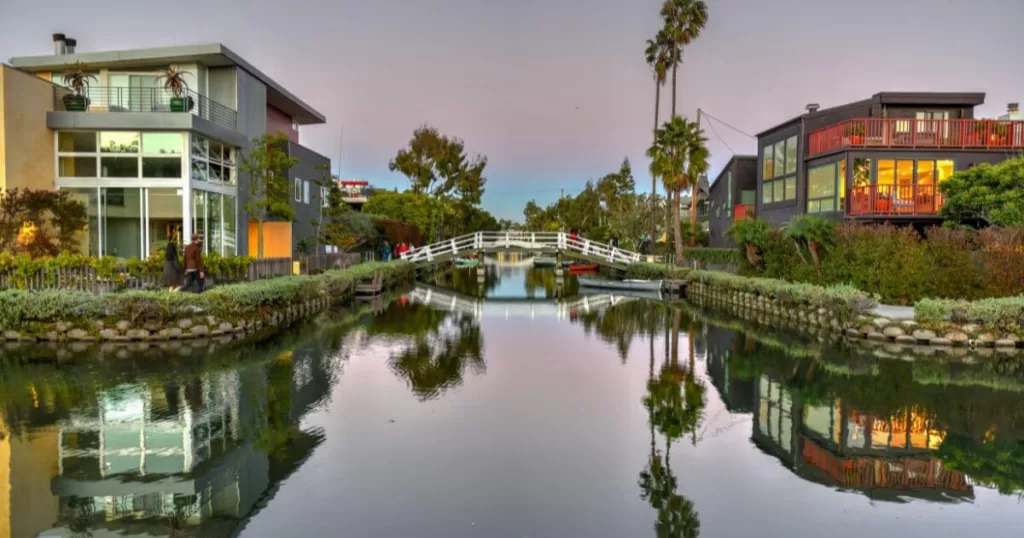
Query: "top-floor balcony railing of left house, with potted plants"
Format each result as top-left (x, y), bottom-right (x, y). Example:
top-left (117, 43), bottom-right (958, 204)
top-left (53, 86), bottom-right (239, 129)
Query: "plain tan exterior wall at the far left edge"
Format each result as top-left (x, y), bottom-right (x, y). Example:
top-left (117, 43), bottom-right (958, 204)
top-left (0, 67), bottom-right (56, 190)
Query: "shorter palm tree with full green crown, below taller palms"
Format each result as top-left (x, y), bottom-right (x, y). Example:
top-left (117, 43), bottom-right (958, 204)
top-left (647, 117), bottom-right (708, 260)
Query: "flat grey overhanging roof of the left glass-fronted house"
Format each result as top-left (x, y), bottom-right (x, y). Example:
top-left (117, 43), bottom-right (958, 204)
top-left (10, 43), bottom-right (327, 125)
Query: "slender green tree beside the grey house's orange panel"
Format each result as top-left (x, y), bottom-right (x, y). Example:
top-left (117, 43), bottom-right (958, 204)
top-left (241, 133), bottom-right (299, 258)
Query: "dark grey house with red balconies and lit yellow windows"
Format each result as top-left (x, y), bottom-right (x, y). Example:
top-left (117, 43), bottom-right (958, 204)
top-left (757, 92), bottom-right (1024, 224)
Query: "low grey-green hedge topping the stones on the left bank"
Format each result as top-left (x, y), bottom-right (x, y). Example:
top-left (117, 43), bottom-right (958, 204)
top-left (0, 261), bottom-right (415, 331)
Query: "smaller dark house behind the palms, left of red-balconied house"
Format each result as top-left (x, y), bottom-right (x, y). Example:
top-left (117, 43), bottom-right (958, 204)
top-left (708, 155), bottom-right (758, 248)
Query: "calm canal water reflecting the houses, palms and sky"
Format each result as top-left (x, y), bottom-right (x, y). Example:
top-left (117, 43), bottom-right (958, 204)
top-left (0, 267), bottom-right (1024, 538)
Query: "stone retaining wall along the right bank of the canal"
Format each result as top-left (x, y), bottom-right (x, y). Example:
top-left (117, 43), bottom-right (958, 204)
top-left (686, 282), bottom-right (1022, 355)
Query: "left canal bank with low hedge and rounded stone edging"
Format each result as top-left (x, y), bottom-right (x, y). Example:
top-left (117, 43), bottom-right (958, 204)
top-left (0, 261), bottom-right (416, 343)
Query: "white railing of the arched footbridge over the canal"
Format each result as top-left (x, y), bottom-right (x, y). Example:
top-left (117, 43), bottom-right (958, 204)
top-left (401, 232), bottom-right (641, 265)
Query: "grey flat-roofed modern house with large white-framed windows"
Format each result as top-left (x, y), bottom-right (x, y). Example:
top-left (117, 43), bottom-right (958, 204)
top-left (0, 34), bottom-right (330, 257)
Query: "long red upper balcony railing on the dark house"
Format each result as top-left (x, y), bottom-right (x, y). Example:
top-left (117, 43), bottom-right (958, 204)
top-left (808, 118), bottom-right (1024, 157)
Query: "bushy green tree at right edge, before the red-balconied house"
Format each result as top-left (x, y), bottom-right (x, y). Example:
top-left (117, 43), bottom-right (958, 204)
top-left (939, 157), bottom-right (1024, 227)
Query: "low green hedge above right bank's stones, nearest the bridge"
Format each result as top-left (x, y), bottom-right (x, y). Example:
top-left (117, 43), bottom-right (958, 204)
top-left (686, 271), bottom-right (878, 322)
